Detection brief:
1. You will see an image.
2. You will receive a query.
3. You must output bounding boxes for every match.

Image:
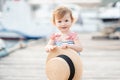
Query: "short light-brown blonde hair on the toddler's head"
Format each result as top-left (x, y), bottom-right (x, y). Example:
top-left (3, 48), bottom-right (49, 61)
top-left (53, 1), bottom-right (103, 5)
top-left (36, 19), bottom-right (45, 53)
top-left (52, 6), bottom-right (74, 24)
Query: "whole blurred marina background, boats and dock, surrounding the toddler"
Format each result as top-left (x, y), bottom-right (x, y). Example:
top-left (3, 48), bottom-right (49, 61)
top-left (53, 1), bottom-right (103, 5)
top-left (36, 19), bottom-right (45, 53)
top-left (0, 0), bottom-right (120, 80)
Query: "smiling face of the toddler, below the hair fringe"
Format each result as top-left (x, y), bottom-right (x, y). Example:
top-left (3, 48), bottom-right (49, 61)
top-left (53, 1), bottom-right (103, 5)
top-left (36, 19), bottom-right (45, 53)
top-left (55, 13), bottom-right (72, 33)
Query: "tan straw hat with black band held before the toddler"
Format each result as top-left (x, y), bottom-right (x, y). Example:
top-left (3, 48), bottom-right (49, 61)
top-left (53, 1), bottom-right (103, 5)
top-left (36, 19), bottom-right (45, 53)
top-left (46, 47), bottom-right (82, 80)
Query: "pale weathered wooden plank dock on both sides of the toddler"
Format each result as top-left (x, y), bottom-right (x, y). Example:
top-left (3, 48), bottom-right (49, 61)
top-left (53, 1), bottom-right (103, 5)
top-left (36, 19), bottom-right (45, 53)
top-left (0, 33), bottom-right (120, 80)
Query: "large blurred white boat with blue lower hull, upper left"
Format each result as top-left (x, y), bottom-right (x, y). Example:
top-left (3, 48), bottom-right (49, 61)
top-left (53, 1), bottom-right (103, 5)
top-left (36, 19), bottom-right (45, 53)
top-left (0, 0), bottom-right (52, 39)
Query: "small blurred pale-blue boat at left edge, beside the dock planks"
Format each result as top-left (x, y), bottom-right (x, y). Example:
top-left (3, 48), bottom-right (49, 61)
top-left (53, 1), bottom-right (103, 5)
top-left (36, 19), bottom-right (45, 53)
top-left (0, 39), bottom-right (27, 58)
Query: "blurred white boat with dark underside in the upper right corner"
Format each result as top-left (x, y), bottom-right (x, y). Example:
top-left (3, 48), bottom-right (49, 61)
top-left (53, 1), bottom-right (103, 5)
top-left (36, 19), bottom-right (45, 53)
top-left (98, 1), bottom-right (120, 22)
